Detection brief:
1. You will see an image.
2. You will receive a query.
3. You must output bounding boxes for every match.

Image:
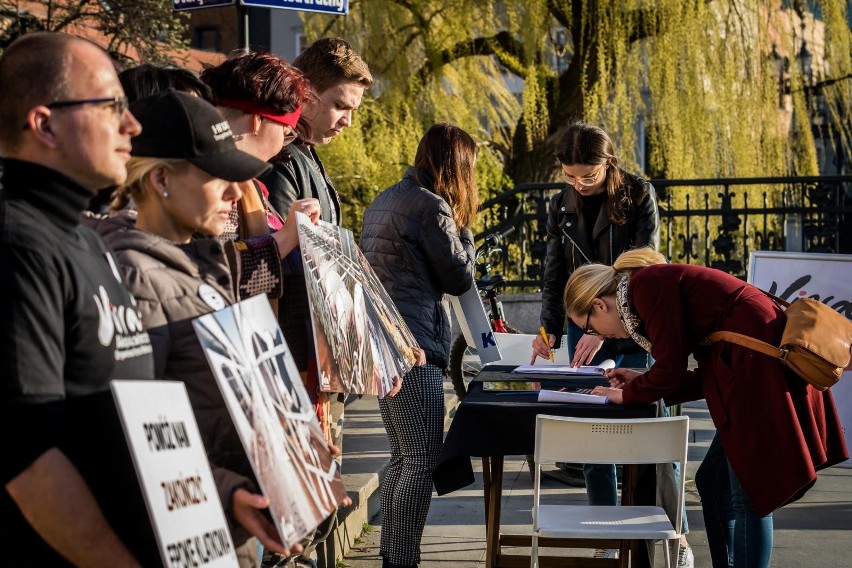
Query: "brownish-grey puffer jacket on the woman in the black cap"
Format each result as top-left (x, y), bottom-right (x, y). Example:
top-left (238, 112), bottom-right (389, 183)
top-left (92, 217), bottom-right (255, 546)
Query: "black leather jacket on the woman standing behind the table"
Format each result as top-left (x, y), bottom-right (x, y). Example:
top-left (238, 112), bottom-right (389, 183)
top-left (541, 170), bottom-right (660, 347)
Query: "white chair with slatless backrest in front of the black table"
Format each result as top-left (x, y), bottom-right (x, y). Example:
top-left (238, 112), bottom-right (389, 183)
top-left (530, 415), bottom-right (689, 568)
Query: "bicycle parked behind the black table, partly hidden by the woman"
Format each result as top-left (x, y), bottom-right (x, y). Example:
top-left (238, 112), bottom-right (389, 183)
top-left (450, 227), bottom-right (521, 400)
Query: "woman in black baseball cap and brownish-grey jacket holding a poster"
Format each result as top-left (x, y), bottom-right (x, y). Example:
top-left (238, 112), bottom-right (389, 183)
top-left (97, 90), bottom-right (326, 566)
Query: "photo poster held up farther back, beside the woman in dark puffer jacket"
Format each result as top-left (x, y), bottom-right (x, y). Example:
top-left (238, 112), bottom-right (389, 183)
top-left (296, 214), bottom-right (417, 398)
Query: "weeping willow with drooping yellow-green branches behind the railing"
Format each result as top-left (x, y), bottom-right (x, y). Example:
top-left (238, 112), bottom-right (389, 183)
top-left (305, 0), bottom-right (852, 229)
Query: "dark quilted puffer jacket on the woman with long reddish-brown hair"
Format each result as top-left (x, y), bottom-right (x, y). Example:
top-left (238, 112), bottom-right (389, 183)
top-left (360, 168), bottom-right (475, 369)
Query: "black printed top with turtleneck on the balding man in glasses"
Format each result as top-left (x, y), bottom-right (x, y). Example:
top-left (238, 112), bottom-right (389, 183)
top-left (0, 160), bottom-right (160, 566)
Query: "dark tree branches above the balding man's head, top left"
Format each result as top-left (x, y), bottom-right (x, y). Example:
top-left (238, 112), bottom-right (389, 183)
top-left (0, 0), bottom-right (188, 62)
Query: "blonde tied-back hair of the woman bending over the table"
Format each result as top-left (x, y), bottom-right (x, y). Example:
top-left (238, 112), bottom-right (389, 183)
top-left (564, 247), bottom-right (666, 316)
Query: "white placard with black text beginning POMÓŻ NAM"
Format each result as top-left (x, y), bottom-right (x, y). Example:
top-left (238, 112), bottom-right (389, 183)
top-left (111, 381), bottom-right (238, 568)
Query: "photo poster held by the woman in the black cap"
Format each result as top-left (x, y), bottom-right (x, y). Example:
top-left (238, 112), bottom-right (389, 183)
top-left (193, 294), bottom-right (346, 548)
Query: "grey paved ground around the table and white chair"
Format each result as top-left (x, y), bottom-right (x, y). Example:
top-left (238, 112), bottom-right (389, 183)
top-left (337, 385), bottom-right (852, 568)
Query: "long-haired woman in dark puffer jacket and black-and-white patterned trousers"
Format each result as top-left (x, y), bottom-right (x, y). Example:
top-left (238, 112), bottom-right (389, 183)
top-left (361, 124), bottom-right (479, 567)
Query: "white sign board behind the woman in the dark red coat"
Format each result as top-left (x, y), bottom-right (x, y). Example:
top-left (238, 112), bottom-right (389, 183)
top-left (748, 251), bottom-right (852, 467)
